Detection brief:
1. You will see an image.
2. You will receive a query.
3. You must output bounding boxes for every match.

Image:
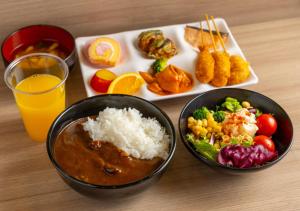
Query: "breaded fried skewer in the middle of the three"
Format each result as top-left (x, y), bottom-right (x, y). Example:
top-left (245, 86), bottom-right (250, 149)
top-left (210, 51), bottom-right (230, 87)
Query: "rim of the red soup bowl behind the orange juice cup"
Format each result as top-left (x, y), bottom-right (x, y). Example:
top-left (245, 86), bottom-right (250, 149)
top-left (1, 24), bottom-right (76, 66)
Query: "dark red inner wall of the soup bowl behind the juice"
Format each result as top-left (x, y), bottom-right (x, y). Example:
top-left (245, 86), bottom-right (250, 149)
top-left (1, 25), bottom-right (75, 66)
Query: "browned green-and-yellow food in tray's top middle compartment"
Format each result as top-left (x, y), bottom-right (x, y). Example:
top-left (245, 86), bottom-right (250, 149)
top-left (138, 30), bottom-right (177, 59)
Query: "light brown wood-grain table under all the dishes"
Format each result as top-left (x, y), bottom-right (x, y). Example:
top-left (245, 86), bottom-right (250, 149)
top-left (0, 0), bottom-right (300, 210)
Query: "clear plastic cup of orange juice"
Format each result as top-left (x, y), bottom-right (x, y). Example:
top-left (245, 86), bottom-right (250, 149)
top-left (4, 53), bottom-right (69, 142)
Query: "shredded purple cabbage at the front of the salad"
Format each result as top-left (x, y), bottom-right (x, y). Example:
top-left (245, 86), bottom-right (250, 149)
top-left (217, 144), bottom-right (278, 168)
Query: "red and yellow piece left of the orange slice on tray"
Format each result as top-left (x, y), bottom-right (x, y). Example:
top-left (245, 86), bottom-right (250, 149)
top-left (90, 69), bottom-right (117, 93)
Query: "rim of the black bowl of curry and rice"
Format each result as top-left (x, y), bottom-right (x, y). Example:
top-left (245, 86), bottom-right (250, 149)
top-left (46, 94), bottom-right (176, 189)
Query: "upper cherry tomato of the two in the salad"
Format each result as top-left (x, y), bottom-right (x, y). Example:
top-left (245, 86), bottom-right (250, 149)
top-left (256, 114), bottom-right (277, 136)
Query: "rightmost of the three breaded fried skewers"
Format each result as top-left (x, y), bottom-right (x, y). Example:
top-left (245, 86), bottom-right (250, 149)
top-left (228, 55), bottom-right (250, 85)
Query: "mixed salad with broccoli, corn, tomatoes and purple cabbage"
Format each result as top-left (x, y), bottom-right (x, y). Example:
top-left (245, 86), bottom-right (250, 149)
top-left (186, 97), bottom-right (278, 168)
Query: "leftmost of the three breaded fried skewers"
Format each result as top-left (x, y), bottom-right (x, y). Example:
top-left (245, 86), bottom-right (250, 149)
top-left (195, 48), bottom-right (215, 83)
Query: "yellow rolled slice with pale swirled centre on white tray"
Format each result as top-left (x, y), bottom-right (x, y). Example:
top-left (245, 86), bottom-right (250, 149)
top-left (88, 37), bottom-right (121, 67)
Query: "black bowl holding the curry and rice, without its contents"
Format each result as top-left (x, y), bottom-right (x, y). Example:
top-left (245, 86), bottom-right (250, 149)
top-left (46, 95), bottom-right (176, 197)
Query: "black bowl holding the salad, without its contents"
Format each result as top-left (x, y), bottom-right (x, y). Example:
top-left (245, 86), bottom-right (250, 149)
top-left (178, 88), bottom-right (293, 174)
